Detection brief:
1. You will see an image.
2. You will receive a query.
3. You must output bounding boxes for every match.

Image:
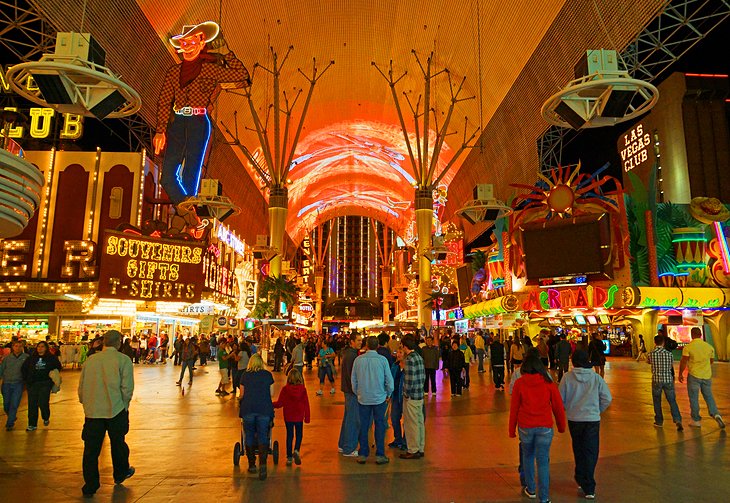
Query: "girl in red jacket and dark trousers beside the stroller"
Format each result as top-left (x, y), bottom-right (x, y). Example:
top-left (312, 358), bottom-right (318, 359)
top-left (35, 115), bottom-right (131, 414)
top-left (274, 368), bottom-right (309, 466)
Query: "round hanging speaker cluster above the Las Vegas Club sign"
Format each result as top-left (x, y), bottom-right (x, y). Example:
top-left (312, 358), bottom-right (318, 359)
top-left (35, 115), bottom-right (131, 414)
top-left (542, 49), bottom-right (659, 129)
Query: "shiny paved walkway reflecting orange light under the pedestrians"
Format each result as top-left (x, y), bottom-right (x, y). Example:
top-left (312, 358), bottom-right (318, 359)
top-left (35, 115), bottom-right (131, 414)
top-left (0, 360), bottom-right (730, 503)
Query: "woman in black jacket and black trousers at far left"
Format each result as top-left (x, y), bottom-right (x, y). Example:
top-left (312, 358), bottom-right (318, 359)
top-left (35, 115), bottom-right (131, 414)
top-left (23, 341), bottom-right (61, 431)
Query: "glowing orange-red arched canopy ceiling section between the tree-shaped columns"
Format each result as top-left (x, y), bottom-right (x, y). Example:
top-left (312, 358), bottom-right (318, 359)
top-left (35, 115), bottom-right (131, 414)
top-left (287, 121), bottom-right (453, 242)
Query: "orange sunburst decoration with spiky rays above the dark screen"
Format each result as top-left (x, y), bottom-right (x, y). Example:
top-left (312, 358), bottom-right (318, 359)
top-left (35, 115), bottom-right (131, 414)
top-left (510, 162), bottom-right (620, 225)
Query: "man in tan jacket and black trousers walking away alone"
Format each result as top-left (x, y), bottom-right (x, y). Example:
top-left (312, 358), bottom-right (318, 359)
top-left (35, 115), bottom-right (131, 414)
top-left (79, 330), bottom-right (134, 497)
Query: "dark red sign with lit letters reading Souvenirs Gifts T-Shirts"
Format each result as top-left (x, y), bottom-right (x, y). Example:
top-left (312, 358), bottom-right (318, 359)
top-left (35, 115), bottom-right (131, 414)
top-left (99, 231), bottom-right (204, 303)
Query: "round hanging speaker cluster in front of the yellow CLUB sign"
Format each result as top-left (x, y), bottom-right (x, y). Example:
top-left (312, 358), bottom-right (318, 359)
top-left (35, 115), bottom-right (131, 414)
top-left (6, 32), bottom-right (142, 119)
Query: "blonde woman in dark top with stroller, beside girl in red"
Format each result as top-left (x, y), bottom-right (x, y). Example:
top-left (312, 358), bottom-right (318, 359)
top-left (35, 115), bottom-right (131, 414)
top-left (238, 353), bottom-right (274, 480)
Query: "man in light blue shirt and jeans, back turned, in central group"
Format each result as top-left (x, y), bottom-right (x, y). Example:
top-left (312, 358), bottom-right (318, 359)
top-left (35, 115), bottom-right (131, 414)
top-left (352, 336), bottom-right (393, 465)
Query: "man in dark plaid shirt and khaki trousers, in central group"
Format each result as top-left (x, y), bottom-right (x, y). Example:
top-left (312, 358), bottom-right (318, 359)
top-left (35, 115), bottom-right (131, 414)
top-left (400, 334), bottom-right (426, 459)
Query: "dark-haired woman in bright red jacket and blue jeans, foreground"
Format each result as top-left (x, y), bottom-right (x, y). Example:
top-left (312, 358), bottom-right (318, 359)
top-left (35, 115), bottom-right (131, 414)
top-left (509, 352), bottom-right (566, 503)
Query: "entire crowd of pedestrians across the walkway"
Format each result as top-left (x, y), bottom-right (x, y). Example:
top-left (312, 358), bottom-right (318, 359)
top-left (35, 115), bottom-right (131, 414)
top-left (0, 328), bottom-right (725, 503)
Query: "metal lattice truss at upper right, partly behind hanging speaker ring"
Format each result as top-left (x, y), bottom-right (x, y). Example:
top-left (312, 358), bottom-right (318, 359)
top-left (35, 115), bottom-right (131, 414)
top-left (537, 0), bottom-right (730, 173)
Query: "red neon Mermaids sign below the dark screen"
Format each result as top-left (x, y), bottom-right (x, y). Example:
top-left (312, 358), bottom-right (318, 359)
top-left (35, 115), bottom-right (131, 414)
top-left (522, 285), bottom-right (618, 311)
